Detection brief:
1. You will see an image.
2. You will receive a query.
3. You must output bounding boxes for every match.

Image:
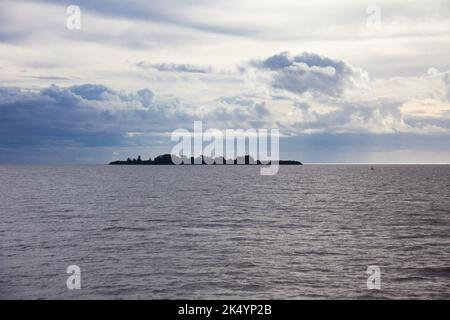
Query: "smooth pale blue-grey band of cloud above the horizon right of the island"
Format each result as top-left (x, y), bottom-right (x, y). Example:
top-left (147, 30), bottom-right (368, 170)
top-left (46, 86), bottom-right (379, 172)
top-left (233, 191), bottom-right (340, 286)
top-left (280, 133), bottom-right (450, 163)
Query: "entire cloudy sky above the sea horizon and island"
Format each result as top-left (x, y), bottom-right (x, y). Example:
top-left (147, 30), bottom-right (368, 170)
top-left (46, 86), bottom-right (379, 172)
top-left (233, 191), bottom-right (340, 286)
top-left (0, 0), bottom-right (450, 163)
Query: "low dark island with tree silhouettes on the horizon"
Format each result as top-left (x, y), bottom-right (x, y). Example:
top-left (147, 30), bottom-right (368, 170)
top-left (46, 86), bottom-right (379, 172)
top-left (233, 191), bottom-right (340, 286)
top-left (109, 154), bottom-right (303, 166)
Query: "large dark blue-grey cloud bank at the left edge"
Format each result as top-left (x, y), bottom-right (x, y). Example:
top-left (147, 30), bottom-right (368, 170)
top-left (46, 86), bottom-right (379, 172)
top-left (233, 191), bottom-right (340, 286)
top-left (0, 84), bottom-right (189, 147)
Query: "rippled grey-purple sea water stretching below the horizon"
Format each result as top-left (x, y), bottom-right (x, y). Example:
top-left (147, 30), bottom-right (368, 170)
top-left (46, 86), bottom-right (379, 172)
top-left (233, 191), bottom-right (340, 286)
top-left (0, 165), bottom-right (450, 299)
